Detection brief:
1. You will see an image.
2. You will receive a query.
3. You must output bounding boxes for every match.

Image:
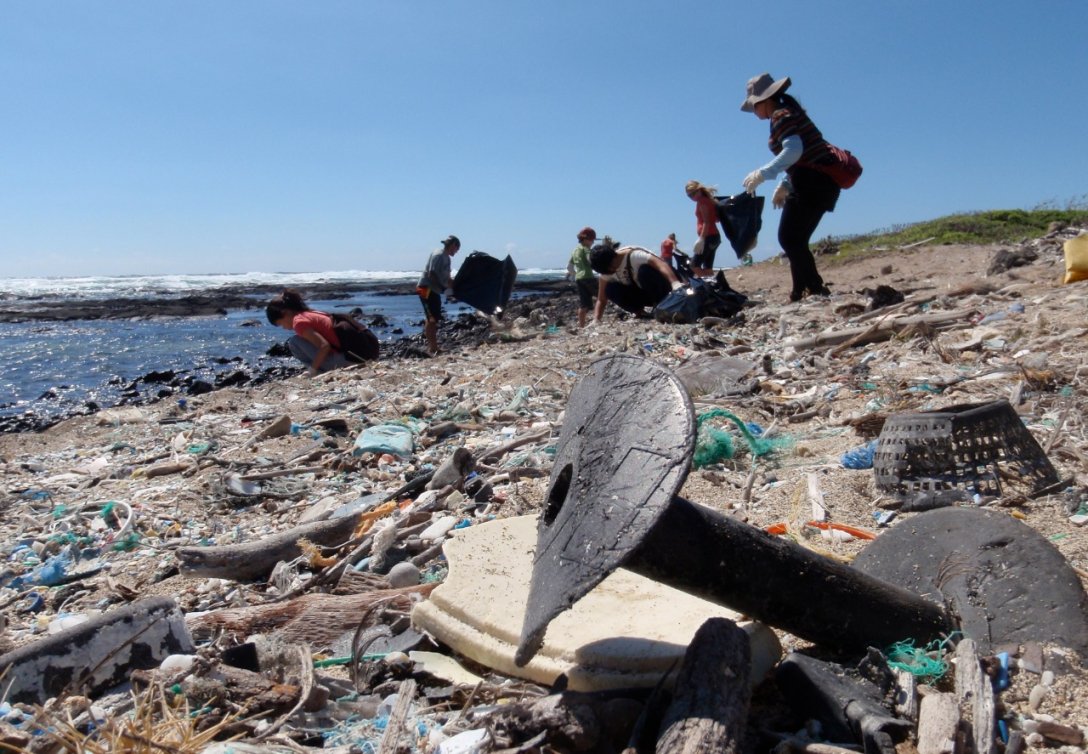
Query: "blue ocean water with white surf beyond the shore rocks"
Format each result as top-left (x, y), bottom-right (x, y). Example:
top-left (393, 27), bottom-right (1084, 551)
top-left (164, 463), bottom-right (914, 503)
top-left (0, 270), bottom-right (562, 423)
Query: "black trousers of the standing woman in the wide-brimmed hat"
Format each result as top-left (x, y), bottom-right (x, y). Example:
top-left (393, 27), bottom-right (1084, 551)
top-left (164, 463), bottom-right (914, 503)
top-left (778, 168), bottom-right (840, 299)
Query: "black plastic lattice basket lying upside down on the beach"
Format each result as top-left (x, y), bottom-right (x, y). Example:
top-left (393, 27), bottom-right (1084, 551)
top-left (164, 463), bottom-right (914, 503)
top-left (873, 400), bottom-right (1058, 505)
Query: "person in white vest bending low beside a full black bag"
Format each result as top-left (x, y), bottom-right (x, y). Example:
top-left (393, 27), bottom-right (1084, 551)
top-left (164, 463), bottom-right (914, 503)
top-left (590, 236), bottom-right (683, 322)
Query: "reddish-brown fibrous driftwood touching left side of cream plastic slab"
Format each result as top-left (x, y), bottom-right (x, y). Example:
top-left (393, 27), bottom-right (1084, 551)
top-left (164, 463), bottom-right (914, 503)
top-left (185, 584), bottom-right (435, 646)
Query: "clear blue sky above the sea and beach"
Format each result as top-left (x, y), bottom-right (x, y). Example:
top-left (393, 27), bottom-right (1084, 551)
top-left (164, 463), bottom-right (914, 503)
top-left (0, 0), bottom-right (1088, 277)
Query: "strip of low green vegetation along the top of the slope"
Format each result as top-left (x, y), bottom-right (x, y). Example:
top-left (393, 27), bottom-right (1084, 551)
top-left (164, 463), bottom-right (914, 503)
top-left (813, 201), bottom-right (1088, 258)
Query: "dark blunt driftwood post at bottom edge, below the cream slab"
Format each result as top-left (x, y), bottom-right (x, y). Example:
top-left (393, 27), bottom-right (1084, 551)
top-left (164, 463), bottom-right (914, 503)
top-left (656, 618), bottom-right (752, 754)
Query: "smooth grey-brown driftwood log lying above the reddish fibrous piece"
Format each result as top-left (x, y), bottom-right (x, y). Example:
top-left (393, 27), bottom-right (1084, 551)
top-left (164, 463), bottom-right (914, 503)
top-left (175, 516), bottom-right (358, 581)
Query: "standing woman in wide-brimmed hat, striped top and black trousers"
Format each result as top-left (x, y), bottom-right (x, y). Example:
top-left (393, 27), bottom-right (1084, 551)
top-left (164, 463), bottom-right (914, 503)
top-left (741, 73), bottom-right (840, 301)
